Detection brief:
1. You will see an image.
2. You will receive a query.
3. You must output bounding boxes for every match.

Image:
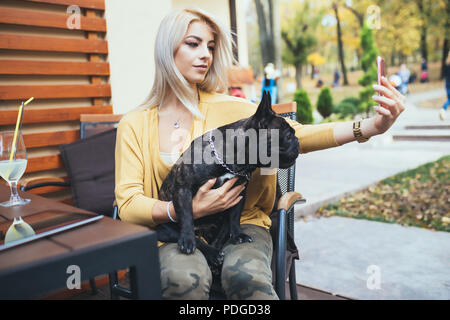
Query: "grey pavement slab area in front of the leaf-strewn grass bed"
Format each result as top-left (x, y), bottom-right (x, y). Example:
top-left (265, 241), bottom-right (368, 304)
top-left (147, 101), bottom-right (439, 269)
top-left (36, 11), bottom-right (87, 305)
top-left (295, 217), bottom-right (450, 300)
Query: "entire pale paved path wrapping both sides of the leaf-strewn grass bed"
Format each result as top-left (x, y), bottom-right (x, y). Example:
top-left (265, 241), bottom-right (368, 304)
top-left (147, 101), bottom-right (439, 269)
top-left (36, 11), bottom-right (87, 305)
top-left (295, 90), bottom-right (450, 299)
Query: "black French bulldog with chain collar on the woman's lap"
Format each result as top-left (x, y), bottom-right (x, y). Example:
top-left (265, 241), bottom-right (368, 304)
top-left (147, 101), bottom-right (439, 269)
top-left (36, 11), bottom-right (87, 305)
top-left (156, 92), bottom-right (300, 274)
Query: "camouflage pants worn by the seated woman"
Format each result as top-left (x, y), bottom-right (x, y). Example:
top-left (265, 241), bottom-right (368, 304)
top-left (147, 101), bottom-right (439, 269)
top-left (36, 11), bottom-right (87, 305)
top-left (159, 225), bottom-right (278, 300)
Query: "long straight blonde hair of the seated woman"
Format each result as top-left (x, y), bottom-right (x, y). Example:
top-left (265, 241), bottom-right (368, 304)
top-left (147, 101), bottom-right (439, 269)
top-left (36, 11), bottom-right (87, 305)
top-left (140, 8), bottom-right (234, 119)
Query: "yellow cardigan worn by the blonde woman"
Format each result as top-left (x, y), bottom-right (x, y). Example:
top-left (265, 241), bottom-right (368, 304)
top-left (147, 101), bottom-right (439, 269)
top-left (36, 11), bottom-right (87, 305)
top-left (115, 92), bottom-right (338, 228)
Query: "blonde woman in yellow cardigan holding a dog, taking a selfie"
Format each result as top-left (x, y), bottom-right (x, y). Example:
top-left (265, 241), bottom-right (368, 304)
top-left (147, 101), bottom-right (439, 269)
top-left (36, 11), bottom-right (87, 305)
top-left (115, 9), bottom-right (404, 299)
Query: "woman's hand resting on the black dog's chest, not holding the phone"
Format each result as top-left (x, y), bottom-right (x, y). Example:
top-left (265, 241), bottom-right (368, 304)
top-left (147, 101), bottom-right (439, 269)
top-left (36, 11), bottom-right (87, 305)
top-left (192, 177), bottom-right (246, 219)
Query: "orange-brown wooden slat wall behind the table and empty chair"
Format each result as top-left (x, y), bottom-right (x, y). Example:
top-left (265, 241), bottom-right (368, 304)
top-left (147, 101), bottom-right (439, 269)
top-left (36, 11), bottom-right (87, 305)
top-left (0, 0), bottom-right (112, 201)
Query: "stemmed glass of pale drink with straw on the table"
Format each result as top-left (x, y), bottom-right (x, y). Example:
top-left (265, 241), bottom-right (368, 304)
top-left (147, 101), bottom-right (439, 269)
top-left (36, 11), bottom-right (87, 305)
top-left (0, 130), bottom-right (31, 207)
